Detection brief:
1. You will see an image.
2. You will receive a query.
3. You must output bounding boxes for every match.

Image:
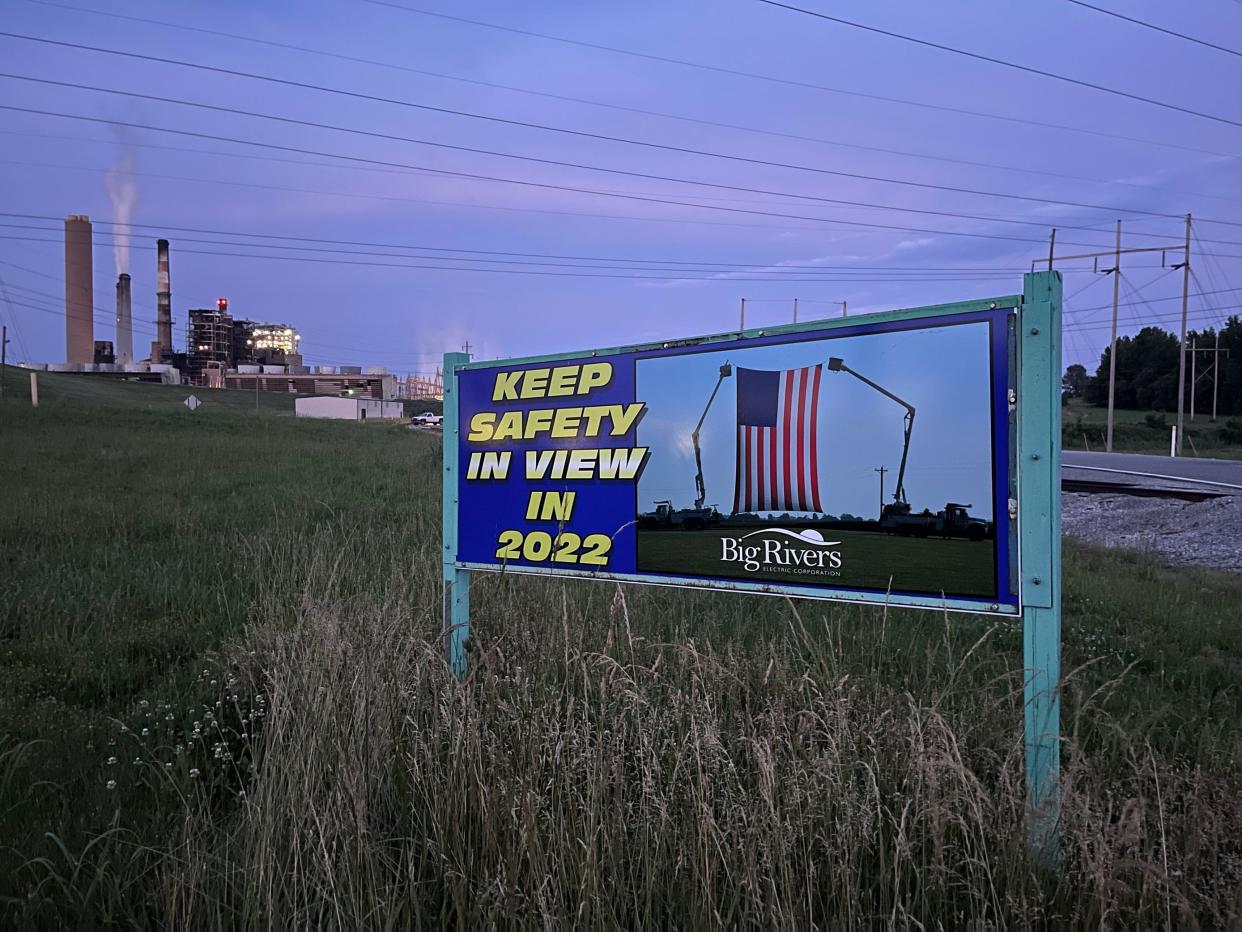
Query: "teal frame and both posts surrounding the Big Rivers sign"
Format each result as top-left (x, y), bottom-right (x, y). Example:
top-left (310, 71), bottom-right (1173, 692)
top-left (442, 271), bottom-right (1061, 867)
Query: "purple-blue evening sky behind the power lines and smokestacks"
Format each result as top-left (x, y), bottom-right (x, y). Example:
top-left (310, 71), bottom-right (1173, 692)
top-left (0, 0), bottom-right (1242, 373)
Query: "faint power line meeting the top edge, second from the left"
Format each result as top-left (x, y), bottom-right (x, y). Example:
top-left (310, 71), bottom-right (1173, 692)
top-left (355, 0), bottom-right (1233, 158)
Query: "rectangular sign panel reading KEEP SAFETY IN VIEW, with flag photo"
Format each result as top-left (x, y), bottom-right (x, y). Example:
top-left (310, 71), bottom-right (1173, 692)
top-left (445, 297), bottom-right (1021, 614)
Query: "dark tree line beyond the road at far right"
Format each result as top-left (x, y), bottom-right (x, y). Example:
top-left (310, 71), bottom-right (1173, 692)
top-left (1061, 314), bottom-right (1242, 415)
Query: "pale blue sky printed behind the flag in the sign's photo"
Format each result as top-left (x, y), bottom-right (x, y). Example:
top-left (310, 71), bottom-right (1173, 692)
top-left (635, 323), bottom-right (992, 519)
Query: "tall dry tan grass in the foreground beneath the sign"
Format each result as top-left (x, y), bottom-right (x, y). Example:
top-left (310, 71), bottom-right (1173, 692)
top-left (138, 531), bottom-right (1242, 928)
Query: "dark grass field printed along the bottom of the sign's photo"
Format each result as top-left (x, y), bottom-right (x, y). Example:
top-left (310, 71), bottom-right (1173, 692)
top-left (637, 528), bottom-right (996, 598)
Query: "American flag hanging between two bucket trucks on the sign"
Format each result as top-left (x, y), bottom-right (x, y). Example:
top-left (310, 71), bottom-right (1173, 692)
top-left (733, 364), bottom-right (823, 514)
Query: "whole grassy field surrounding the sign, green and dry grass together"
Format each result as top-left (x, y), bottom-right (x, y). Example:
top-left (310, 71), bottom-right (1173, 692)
top-left (0, 370), bottom-right (1242, 928)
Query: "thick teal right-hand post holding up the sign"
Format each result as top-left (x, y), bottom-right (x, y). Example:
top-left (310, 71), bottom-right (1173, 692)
top-left (1017, 272), bottom-right (1061, 871)
